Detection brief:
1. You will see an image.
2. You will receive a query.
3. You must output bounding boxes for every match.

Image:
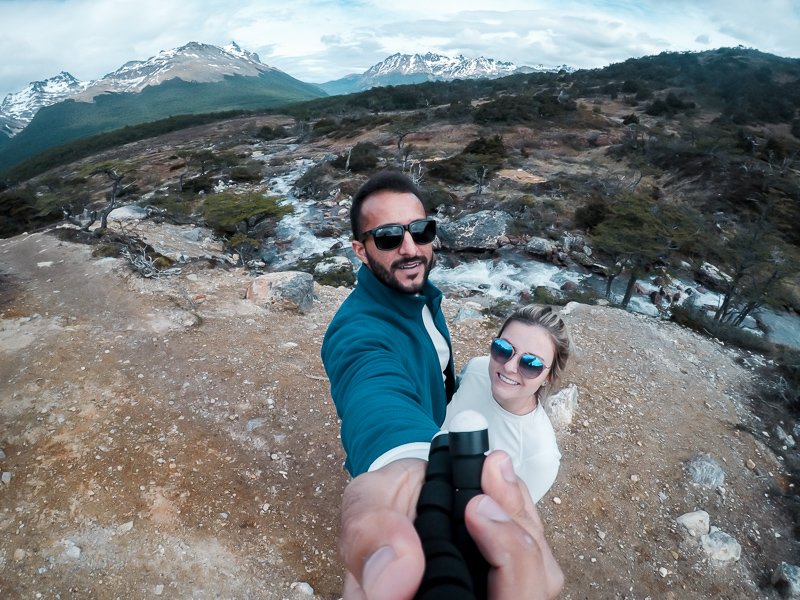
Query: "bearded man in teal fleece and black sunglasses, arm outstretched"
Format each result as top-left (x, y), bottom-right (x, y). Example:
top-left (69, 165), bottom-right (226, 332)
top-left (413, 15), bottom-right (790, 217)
top-left (322, 171), bottom-right (563, 600)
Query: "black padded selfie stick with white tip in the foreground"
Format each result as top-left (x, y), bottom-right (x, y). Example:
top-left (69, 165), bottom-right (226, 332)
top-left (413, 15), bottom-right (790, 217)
top-left (414, 410), bottom-right (489, 600)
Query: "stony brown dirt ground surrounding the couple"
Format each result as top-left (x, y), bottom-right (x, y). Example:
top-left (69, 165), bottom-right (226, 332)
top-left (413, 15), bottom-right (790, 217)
top-left (0, 227), bottom-right (797, 600)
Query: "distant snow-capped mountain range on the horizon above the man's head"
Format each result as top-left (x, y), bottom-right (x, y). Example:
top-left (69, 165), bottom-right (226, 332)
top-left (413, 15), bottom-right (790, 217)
top-left (320, 52), bottom-right (573, 94)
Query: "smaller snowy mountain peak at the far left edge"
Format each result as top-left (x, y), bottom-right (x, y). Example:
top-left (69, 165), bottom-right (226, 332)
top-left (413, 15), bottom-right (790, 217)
top-left (0, 71), bottom-right (91, 137)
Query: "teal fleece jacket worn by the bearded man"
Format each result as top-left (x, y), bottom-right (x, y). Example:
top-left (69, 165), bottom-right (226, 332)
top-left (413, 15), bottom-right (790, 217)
top-left (322, 266), bottom-right (454, 477)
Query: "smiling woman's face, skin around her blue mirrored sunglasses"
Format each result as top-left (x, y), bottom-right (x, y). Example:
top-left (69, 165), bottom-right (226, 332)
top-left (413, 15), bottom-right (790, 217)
top-left (489, 321), bottom-right (555, 415)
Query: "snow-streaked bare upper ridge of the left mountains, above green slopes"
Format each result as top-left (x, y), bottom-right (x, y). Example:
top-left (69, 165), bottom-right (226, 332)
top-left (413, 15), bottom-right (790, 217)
top-left (0, 42), bottom-right (277, 137)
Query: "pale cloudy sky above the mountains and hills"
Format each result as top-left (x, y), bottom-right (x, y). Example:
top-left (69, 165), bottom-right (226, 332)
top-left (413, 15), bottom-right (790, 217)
top-left (0, 0), bottom-right (800, 99)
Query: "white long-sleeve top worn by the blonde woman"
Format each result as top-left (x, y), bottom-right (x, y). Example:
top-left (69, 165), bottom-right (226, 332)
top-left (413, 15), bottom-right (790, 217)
top-left (442, 356), bottom-right (561, 502)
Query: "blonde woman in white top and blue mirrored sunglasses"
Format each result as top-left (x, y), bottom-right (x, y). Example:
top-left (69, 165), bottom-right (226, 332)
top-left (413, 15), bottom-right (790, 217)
top-left (442, 304), bottom-right (572, 502)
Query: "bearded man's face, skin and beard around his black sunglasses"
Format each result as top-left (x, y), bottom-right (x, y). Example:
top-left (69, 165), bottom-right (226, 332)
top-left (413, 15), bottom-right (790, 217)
top-left (353, 191), bottom-right (435, 294)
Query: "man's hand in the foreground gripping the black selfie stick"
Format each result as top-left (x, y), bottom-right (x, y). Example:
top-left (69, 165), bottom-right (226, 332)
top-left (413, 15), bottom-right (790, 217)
top-left (339, 451), bottom-right (564, 600)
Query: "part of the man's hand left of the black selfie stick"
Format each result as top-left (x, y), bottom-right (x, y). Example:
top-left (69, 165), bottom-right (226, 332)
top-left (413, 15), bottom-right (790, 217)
top-left (339, 461), bottom-right (425, 600)
